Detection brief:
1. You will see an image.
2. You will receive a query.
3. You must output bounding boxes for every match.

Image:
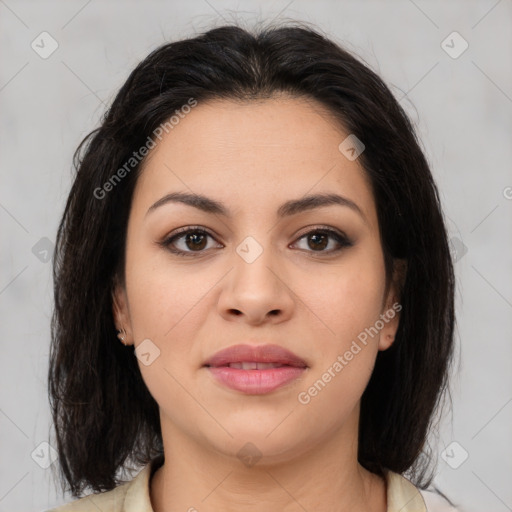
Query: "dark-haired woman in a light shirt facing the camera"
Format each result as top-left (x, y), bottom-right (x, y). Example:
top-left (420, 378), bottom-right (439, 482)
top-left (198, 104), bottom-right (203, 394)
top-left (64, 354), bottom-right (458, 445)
top-left (49, 24), bottom-right (454, 512)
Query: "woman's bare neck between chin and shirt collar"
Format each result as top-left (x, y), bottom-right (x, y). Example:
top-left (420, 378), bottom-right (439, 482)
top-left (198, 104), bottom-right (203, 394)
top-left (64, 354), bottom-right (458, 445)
top-left (150, 410), bottom-right (387, 512)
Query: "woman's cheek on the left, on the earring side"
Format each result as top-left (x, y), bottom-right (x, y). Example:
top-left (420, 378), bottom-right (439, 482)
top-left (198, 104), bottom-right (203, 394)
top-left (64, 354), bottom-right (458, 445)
top-left (126, 252), bottom-right (210, 431)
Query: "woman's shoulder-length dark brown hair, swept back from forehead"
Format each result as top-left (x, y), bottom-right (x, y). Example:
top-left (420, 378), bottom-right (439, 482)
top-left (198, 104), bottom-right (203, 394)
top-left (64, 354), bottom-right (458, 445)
top-left (48, 19), bottom-right (454, 497)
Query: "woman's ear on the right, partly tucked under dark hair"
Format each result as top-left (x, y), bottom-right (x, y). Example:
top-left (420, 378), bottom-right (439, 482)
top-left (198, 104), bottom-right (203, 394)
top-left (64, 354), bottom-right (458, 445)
top-left (379, 259), bottom-right (407, 350)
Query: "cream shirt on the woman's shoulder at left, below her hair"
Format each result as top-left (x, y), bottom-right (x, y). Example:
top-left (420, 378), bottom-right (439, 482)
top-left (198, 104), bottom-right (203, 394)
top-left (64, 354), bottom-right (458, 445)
top-left (46, 464), bottom-right (153, 512)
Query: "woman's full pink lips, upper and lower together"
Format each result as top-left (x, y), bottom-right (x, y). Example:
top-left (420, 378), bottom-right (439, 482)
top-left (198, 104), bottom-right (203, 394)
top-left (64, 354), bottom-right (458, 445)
top-left (205, 345), bottom-right (307, 395)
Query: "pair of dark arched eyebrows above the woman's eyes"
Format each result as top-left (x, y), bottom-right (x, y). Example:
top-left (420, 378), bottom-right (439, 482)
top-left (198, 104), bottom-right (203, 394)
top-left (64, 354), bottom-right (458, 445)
top-left (146, 192), bottom-right (367, 222)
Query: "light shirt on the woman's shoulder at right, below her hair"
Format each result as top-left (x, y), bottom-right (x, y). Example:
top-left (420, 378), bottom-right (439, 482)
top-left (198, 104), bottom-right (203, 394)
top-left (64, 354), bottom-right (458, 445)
top-left (385, 470), bottom-right (458, 512)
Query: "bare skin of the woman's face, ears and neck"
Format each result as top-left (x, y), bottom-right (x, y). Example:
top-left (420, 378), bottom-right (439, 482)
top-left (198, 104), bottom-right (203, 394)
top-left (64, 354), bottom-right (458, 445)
top-left (114, 96), bottom-right (399, 512)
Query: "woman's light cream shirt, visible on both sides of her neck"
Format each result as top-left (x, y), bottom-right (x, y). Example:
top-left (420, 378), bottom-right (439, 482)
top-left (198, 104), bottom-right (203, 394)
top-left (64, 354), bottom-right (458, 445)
top-left (46, 459), bottom-right (457, 512)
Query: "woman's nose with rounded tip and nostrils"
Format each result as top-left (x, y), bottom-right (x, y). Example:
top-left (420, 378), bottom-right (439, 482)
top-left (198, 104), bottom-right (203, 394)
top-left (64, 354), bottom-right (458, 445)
top-left (218, 239), bottom-right (295, 325)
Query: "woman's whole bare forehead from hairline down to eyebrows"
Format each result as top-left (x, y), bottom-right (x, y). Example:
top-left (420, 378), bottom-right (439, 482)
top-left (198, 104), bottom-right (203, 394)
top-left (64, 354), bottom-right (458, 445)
top-left (136, 97), bottom-right (375, 224)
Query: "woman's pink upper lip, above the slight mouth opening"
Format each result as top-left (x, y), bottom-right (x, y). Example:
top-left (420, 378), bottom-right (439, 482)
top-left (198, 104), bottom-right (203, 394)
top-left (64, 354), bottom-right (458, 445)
top-left (204, 345), bottom-right (307, 370)
